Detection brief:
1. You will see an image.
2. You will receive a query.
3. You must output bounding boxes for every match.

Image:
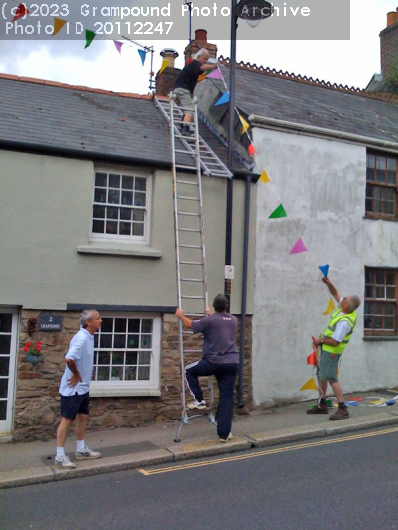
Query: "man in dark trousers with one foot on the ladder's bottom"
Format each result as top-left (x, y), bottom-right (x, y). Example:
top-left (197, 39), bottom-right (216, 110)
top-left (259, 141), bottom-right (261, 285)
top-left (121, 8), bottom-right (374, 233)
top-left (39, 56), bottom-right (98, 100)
top-left (176, 294), bottom-right (239, 443)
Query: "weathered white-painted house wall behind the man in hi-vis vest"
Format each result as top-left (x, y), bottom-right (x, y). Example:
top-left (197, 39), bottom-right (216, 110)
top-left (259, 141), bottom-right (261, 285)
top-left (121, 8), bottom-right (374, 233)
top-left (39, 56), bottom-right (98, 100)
top-left (253, 128), bottom-right (398, 405)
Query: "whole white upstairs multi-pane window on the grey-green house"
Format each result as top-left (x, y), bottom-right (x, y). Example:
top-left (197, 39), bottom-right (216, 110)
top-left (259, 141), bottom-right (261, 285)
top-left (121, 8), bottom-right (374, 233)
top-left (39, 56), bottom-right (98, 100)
top-left (91, 169), bottom-right (151, 243)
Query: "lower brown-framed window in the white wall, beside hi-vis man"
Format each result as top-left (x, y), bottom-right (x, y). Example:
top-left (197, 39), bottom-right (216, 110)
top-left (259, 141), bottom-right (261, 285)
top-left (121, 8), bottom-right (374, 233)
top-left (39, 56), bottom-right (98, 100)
top-left (364, 267), bottom-right (398, 336)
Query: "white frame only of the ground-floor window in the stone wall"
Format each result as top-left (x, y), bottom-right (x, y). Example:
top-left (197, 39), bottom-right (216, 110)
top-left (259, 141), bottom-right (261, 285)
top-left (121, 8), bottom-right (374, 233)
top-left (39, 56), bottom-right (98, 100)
top-left (90, 312), bottom-right (162, 397)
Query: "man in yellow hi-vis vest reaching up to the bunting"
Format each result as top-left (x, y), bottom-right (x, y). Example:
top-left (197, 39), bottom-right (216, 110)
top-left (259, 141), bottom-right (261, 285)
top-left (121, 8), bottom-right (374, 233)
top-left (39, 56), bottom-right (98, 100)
top-left (307, 278), bottom-right (361, 420)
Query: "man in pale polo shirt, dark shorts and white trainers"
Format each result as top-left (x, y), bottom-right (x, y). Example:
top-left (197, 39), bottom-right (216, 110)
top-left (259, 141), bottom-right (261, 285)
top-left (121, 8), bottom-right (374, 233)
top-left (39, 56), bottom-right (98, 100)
top-left (55, 309), bottom-right (102, 469)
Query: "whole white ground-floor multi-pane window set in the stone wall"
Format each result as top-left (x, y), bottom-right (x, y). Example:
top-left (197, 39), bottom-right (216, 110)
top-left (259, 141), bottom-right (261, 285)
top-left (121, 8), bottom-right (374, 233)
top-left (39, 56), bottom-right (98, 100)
top-left (90, 313), bottom-right (161, 397)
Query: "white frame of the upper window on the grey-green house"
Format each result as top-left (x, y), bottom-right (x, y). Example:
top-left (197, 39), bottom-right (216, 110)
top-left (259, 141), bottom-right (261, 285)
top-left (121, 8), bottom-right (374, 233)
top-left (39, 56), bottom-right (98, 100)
top-left (90, 165), bottom-right (153, 245)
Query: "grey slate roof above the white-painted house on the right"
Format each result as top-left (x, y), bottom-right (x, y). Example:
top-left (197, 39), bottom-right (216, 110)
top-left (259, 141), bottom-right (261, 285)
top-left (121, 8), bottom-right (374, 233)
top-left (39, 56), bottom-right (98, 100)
top-left (206, 64), bottom-right (398, 143)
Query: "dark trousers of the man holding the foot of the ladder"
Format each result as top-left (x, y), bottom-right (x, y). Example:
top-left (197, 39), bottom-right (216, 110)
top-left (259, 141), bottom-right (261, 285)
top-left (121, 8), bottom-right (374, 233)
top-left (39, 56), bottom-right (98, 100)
top-left (185, 359), bottom-right (239, 439)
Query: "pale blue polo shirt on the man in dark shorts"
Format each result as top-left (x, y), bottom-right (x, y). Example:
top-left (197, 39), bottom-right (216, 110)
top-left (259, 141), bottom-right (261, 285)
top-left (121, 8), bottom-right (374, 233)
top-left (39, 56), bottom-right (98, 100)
top-left (59, 328), bottom-right (94, 396)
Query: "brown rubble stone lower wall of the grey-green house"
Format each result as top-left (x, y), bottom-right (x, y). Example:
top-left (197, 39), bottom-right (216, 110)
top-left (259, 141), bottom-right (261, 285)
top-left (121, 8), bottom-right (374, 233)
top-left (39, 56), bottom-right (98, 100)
top-left (13, 310), bottom-right (252, 440)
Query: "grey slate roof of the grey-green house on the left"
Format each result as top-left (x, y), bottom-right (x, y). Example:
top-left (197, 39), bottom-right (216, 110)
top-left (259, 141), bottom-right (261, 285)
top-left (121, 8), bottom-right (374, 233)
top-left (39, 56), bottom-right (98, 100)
top-left (0, 74), bottom-right (246, 171)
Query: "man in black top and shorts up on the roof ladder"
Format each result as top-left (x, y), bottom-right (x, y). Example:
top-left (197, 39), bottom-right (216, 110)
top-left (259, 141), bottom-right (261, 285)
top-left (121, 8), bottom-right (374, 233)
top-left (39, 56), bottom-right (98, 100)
top-left (173, 48), bottom-right (218, 136)
